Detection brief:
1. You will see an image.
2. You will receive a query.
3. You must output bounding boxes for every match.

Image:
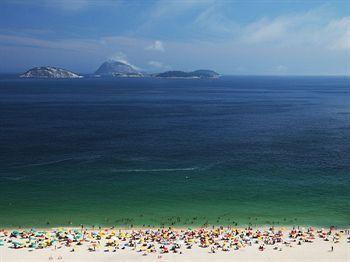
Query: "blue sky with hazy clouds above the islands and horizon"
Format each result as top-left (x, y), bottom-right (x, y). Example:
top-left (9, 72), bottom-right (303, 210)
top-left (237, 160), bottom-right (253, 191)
top-left (0, 0), bottom-right (350, 75)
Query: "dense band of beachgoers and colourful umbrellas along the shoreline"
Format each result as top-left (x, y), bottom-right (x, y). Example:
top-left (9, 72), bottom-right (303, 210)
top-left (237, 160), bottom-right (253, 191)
top-left (0, 227), bottom-right (350, 255)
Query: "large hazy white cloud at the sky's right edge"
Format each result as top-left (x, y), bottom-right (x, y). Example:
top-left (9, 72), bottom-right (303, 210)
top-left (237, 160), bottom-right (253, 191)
top-left (238, 9), bottom-right (350, 50)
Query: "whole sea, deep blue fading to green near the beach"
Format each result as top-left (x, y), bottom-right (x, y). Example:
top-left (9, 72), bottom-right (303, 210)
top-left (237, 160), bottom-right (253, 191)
top-left (0, 77), bottom-right (350, 226)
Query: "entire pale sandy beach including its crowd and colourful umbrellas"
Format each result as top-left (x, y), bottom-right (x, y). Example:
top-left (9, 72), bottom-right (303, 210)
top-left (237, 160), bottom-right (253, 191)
top-left (0, 227), bottom-right (350, 262)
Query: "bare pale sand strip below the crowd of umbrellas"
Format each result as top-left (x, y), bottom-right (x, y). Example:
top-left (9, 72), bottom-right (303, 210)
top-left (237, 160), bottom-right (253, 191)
top-left (0, 234), bottom-right (350, 262)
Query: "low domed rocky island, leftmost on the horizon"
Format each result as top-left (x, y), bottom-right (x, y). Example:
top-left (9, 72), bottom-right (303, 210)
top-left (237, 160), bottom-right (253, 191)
top-left (20, 66), bottom-right (83, 78)
